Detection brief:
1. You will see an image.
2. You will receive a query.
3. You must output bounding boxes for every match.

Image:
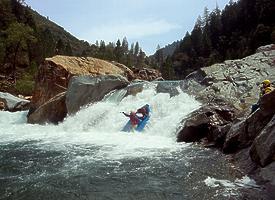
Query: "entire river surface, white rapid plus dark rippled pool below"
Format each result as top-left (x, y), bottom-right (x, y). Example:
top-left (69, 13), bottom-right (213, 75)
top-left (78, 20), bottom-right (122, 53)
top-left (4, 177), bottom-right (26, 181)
top-left (0, 83), bottom-right (258, 200)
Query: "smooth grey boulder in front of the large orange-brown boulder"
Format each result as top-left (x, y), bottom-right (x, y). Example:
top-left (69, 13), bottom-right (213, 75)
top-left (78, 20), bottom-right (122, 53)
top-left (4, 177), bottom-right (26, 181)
top-left (66, 75), bottom-right (129, 114)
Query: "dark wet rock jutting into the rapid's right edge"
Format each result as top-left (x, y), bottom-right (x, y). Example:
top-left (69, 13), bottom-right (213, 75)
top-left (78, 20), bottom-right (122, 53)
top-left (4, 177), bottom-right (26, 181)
top-left (177, 104), bottom-right (235, 146)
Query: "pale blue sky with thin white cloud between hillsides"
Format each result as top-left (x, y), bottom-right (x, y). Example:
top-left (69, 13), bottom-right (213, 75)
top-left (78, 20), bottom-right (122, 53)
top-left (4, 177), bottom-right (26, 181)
top-left (25, 0), bottom-right (232, 55)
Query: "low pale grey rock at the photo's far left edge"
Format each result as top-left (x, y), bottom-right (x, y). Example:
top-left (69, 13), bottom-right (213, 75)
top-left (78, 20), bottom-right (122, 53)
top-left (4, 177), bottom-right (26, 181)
top-left (0, 92), bottom-right (30, 112)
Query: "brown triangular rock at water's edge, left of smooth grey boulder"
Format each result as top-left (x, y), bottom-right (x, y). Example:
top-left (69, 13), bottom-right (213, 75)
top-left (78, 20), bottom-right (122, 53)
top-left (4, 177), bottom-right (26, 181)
top-left (28, 92), bottom-right (67, 124)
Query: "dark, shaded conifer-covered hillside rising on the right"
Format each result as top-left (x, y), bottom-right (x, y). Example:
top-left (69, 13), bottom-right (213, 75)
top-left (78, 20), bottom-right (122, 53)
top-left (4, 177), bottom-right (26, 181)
top-left (151, 0), bottom-right (275, 79)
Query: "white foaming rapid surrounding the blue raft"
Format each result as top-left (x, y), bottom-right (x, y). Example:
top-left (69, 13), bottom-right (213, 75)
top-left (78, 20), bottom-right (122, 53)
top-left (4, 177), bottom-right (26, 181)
top-left (0, 85), bottom-right (203, 159)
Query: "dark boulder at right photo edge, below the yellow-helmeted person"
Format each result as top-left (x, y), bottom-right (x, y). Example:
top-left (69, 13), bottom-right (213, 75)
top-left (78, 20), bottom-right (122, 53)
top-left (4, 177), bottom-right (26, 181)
top-left (250, 115), bottom-right (275, 167)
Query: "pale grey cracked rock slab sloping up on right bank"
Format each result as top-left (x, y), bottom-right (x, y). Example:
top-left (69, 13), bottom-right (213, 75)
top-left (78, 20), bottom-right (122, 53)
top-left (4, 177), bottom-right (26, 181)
top-left (185, 45), bottom-right (275, 109)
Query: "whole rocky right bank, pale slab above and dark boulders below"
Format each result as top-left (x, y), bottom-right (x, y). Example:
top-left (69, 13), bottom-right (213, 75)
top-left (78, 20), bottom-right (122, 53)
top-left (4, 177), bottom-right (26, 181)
top-left (178, 44), bottom-right (275, 195)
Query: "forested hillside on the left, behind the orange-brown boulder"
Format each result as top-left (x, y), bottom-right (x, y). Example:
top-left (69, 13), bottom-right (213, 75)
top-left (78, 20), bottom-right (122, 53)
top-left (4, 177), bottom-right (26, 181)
top-left (0, 0), bottom-right (149, 95)
